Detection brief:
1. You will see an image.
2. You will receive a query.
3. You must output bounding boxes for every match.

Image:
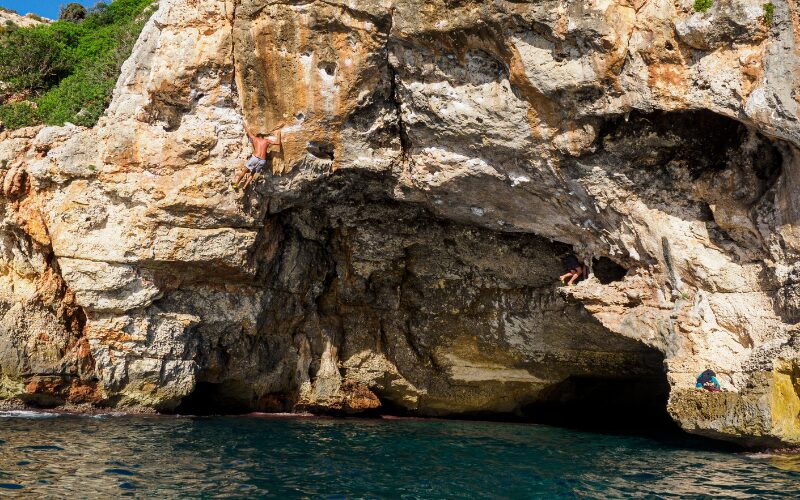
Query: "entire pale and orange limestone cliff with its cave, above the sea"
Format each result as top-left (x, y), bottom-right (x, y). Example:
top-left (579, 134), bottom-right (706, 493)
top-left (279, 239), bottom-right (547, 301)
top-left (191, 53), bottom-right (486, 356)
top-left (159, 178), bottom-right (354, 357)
top-left (0, 0), bottom-right (800, 446)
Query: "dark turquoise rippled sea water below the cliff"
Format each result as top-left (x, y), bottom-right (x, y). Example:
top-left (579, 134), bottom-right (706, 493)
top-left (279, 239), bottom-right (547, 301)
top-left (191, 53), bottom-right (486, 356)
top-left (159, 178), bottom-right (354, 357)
top-left (0, 412), bottom-right (800, 498)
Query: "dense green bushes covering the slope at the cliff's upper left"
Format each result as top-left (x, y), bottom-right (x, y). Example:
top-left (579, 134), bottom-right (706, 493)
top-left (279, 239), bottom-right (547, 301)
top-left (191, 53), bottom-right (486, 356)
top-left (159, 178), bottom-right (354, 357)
top-left (0, 0), bottom-right (154, 129)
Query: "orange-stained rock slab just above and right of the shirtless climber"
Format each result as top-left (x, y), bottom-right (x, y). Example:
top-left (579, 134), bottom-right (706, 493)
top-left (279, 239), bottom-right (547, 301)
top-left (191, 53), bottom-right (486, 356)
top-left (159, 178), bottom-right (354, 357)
top-left (237, 2), bottom-right (384, 173)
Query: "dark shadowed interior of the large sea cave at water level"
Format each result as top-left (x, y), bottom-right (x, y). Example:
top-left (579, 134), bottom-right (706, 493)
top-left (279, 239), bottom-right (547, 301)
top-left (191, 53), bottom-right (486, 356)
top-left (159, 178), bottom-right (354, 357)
top-left (169, 200), bottom-right (672, 431)
